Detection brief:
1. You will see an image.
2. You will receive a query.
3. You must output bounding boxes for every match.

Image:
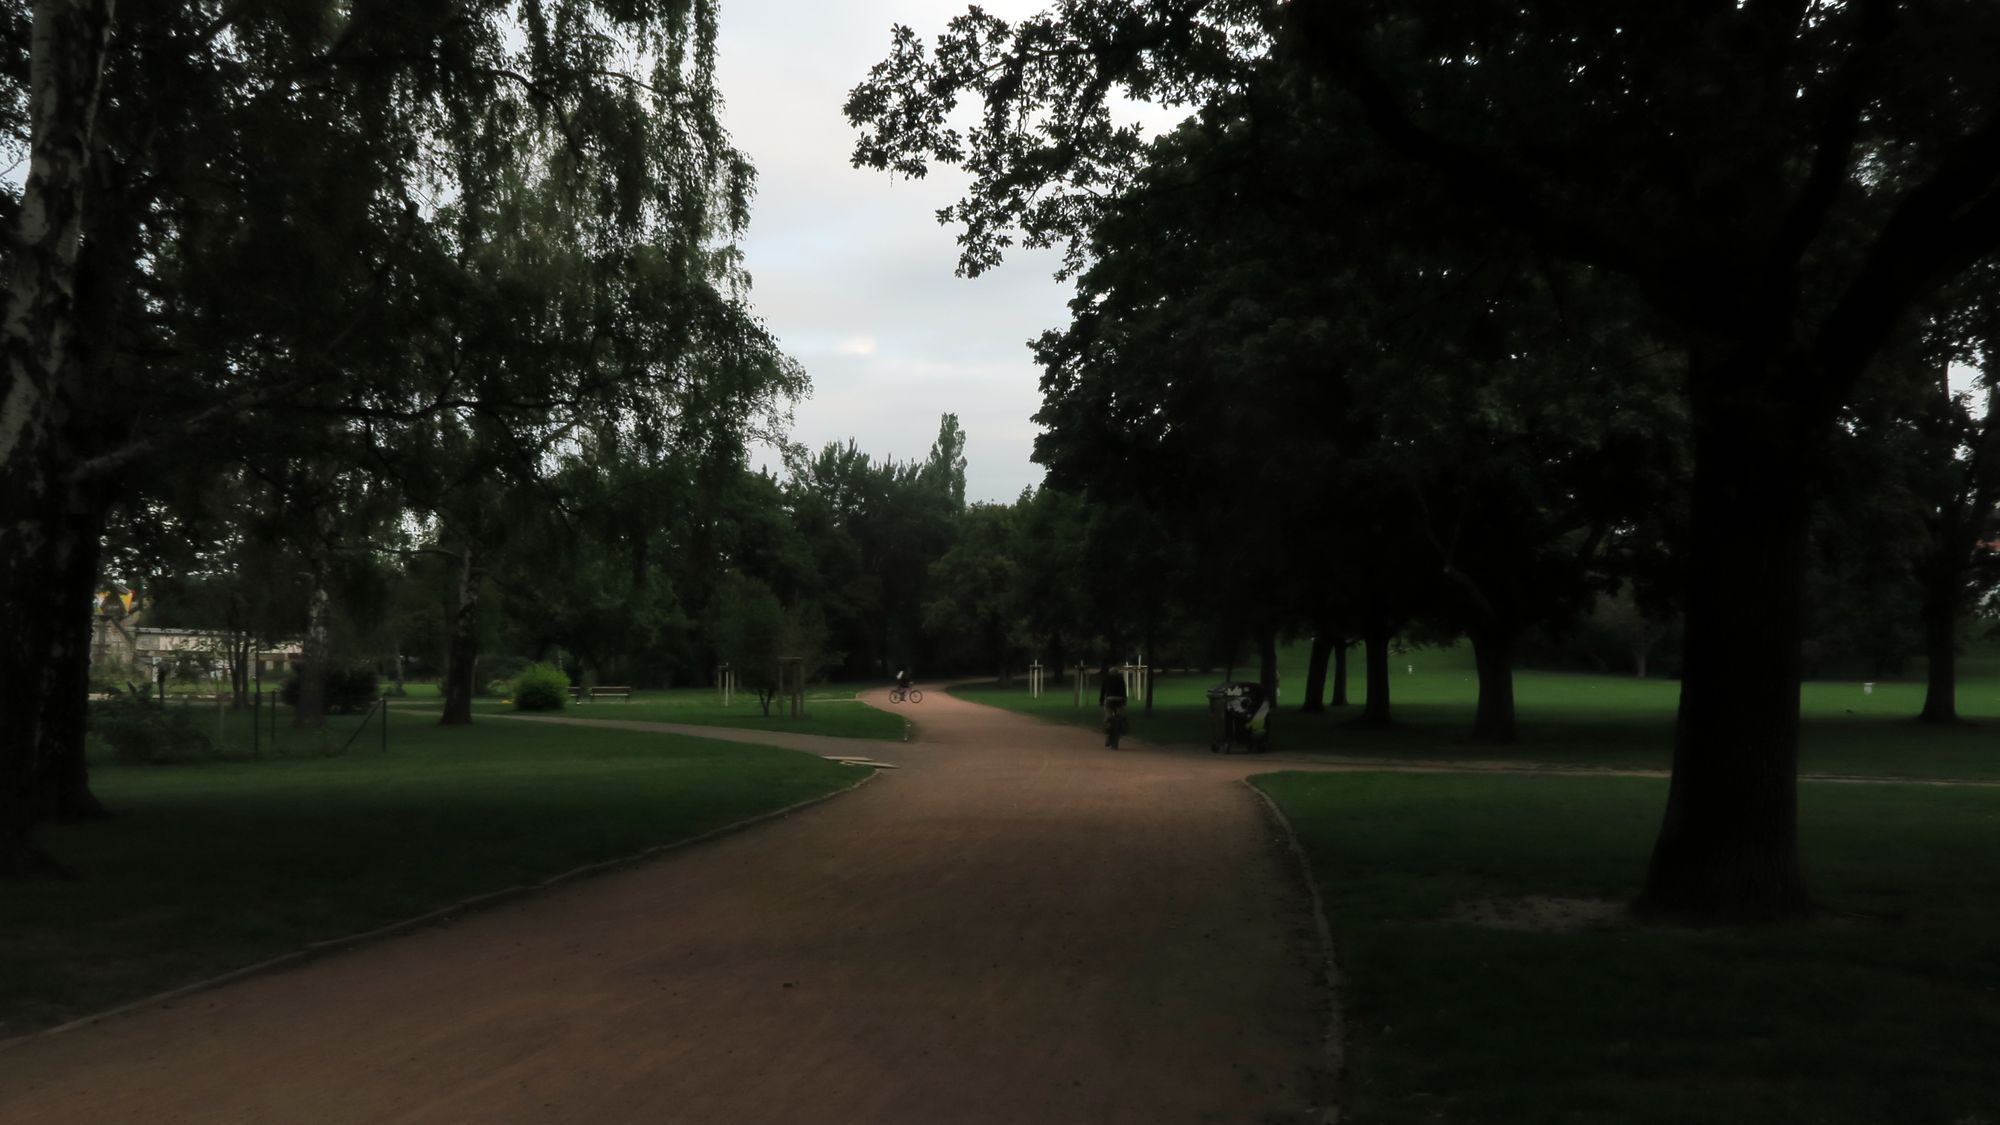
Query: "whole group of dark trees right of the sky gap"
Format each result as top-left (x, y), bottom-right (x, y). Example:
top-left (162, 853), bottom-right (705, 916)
top-left (848, 0), bottom-right (2000, 919)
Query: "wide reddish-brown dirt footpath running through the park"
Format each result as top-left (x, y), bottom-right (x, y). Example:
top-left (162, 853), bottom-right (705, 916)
top-left (0, 691), bottom-right (1326, 1125)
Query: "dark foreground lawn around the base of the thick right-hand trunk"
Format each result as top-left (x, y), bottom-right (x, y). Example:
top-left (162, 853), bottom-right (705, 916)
top-left (1256, 773), bottom-right (2000, 1125)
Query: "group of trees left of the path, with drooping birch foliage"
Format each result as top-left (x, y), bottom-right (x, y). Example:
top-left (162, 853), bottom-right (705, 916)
top-left (0, 0), bottom-right (806, 875)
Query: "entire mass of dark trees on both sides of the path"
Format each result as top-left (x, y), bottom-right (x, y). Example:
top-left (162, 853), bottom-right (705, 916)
top-left (15, 0), bottom-right (2000, 932)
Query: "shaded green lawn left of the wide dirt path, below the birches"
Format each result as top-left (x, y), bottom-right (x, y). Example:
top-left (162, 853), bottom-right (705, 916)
top-left (0, 711), bottom-right (860, 1035)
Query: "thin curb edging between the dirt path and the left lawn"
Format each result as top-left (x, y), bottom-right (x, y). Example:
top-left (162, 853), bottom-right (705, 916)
top-left (0, 767), bottom-right (882, 1051)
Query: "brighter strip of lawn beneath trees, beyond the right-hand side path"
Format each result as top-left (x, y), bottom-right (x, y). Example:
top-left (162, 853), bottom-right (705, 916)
top-left (954, 647), bottom-right (2000, 779)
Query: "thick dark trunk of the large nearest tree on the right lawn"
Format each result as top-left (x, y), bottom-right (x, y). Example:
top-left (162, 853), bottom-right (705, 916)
top-left (1640, 384), bottom-right (1812, 921)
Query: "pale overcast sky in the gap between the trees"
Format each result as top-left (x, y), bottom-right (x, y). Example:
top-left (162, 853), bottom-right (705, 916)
top-left (718, 0), bottom-right (1096, 500)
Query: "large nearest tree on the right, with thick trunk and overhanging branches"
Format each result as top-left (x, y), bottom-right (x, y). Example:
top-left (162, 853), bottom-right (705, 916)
top-left (848, 0), bottom-right (2000, 919)
